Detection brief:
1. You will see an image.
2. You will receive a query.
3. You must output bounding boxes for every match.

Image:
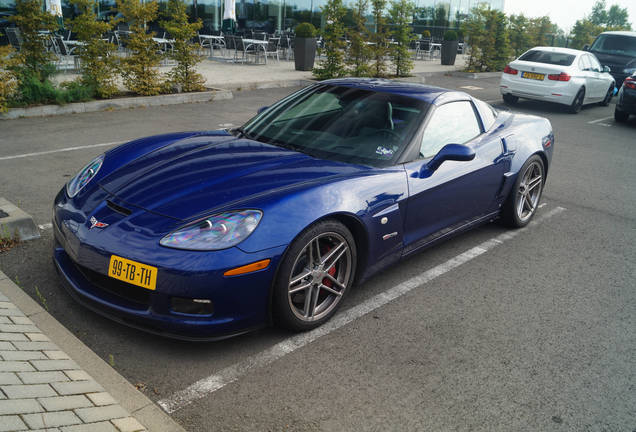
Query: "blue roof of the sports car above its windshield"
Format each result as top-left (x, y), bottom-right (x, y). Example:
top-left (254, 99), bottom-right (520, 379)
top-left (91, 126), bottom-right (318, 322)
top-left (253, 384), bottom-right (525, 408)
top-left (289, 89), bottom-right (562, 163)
top-left (321, 78), bottom-right (470, 105)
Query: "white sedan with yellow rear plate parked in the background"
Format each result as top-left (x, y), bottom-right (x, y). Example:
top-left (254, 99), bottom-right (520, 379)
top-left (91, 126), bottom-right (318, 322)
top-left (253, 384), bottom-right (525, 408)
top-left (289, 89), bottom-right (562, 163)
top-left (499, 47), bottom-right (614, 113)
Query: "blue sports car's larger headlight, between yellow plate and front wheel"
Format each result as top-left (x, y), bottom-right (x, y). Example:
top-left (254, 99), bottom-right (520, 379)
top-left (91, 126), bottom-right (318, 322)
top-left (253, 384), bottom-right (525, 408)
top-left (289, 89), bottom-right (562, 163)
top-left (159, 210), bottom-right (263, 250)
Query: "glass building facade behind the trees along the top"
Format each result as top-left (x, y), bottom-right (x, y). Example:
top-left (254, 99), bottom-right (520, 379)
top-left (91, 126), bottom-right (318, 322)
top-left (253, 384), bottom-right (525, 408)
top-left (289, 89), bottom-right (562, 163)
top-left (0, 0), bottom-right (504, 43)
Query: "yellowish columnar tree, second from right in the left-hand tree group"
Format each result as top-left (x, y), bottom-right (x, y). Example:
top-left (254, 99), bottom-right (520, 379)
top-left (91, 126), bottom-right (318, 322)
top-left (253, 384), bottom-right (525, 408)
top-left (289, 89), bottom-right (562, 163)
top-left (117, 0), bottom-right (161, 96)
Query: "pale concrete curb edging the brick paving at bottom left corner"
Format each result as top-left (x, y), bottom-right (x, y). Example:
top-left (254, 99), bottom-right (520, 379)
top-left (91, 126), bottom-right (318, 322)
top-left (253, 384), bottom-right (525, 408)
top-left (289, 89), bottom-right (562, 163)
top-left (0, 271), bottom-right (186, 432)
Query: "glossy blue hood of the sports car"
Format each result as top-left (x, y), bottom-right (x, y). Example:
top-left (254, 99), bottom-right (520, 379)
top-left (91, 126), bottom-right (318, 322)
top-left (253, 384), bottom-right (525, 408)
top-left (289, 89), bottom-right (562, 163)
top-left (99, 135), bottom-right (369, 220)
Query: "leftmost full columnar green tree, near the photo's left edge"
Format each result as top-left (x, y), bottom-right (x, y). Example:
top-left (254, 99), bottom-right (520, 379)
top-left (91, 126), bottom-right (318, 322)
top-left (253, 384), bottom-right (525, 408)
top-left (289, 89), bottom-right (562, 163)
top-left (9, 0), bottom-right (58, 82)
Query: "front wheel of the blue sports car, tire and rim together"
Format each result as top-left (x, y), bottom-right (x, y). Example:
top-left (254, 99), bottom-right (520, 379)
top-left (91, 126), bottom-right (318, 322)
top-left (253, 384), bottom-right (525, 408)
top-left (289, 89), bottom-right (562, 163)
top-left (272, 219), bottom-right (357, 331)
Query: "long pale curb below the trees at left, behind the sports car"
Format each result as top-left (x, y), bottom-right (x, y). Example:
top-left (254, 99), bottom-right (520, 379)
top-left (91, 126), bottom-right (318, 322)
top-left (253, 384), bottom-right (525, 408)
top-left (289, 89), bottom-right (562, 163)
top-left (0, 89), bottom-right (234, 120)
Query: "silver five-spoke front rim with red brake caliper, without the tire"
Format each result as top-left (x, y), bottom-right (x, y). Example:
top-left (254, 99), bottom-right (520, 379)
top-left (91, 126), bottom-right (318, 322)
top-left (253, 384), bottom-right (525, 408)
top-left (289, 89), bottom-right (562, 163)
top-left (288, 232), bottom-right (352, 322)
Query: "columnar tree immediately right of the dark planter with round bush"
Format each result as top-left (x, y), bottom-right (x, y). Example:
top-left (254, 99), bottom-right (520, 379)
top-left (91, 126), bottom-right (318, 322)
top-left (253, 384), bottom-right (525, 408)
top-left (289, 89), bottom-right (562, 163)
top-left (313, 0), bottom-right (347, 80)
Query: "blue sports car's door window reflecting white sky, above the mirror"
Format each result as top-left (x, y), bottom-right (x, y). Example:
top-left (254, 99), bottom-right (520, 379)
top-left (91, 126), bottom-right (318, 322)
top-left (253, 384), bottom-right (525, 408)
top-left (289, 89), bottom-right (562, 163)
top-left (420, 101), bottom-right (481, 158)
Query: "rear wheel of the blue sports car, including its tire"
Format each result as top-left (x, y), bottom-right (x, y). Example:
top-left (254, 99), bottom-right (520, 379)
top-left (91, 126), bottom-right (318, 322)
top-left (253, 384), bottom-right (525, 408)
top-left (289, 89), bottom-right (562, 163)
top-left (501, 155), bottom-right (545, 228)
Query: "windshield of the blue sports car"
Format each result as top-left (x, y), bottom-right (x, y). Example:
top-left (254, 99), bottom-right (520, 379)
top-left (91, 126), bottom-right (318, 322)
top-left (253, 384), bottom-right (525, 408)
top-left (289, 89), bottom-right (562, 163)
top-left (240, 84), bottom-right (428, 166)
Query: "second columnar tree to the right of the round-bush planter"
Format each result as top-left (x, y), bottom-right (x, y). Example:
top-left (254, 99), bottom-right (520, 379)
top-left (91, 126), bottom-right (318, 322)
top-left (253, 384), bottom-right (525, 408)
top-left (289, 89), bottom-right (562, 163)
top-left (346, 0), bottom-right (371, 77)
